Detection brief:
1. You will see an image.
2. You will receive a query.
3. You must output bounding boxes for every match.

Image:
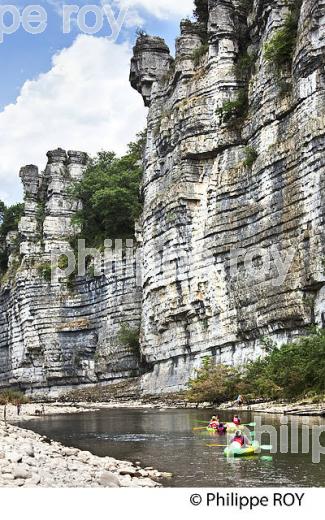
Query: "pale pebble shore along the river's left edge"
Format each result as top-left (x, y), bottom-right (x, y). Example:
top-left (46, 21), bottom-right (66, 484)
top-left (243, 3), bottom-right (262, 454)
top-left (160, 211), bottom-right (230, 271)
top-left (0, 404), bottom-right (172, 489)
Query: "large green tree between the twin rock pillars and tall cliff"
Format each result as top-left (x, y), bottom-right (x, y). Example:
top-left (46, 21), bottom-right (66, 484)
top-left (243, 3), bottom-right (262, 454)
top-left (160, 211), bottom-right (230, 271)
top-left (74, 132), bottom-right (145, 247)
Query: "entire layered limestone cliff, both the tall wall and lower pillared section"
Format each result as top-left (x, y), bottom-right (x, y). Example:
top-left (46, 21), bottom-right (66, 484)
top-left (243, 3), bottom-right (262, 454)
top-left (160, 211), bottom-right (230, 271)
top-left (0, 0), bottom-right (325, 393)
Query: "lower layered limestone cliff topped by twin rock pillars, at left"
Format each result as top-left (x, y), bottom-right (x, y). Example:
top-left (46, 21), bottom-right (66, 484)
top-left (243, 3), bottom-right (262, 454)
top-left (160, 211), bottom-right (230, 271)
top-left (0, 149), bottom-right (141, 395)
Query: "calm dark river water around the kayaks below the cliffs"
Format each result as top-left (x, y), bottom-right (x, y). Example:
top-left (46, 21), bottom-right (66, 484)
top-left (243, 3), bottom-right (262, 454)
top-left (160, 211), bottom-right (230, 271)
top-left (21, 409), bottom-right (325, 487)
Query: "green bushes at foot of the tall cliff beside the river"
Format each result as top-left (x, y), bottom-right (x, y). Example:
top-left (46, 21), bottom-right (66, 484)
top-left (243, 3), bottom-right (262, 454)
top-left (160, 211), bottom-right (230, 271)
top-left (187, 330), bottom-right (325, 403)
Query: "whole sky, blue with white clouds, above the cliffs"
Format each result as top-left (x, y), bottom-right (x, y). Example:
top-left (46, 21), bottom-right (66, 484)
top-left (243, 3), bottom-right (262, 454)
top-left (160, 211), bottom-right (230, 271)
top-left (0, 0), bottom-right (192, 203)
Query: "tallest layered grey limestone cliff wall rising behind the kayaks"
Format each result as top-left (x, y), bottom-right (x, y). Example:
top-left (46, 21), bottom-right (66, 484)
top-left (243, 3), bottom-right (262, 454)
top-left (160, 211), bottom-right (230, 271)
top-left (131, 0), bottom-right (325, 393)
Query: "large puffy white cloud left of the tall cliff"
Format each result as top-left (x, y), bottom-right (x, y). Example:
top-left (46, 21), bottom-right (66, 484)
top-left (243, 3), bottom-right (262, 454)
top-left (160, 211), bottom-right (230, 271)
top-left (0, 35), bottom-right (146, 202)
